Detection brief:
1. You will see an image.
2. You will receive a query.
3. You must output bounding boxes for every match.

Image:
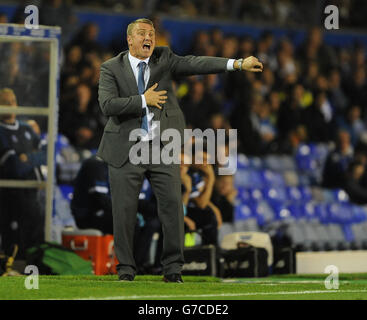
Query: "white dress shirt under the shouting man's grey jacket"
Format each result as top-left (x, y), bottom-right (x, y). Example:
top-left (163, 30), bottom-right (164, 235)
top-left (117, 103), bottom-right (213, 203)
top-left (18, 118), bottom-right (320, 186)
top-left (129, 52), bottom-right (235, 141)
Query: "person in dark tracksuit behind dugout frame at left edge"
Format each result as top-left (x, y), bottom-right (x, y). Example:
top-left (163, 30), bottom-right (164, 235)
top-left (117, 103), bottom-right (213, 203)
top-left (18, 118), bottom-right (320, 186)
top-left (0, 88), bottom-right (46, 259)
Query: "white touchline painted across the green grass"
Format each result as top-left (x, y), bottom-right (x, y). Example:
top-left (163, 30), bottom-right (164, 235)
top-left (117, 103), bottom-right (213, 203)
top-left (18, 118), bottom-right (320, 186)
top-left (69, 290), bottom-right (367, 300)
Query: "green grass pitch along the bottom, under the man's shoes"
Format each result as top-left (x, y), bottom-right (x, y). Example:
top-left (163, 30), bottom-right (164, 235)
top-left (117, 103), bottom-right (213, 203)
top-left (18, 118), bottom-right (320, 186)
top-left (0, 274), bottom-right (367, 300)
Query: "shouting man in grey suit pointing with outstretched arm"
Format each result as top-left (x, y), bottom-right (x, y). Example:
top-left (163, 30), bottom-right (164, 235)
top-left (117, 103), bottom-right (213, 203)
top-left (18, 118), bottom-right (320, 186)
top-left (97, 19), bottom-right (263, 282)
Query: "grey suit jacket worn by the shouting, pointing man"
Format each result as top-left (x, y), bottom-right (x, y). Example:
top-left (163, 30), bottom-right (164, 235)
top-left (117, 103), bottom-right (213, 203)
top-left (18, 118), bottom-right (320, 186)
top-left (97, 47), bottom-right (228, 167)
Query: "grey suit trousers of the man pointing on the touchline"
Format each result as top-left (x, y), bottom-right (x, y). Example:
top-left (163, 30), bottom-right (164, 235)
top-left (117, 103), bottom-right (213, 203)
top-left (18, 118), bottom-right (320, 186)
top-left (108, 143), bottom-right (184, 276)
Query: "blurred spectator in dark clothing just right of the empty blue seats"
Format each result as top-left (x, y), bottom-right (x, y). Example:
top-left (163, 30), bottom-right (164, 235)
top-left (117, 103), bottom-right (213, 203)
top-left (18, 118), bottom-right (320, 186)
top-left (322, 129), bottom-right (353, 189)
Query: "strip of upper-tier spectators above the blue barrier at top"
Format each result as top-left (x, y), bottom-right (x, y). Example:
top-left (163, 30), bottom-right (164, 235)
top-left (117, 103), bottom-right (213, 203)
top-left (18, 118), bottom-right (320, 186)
top-left (61, 0), bottom-right (367, 28)
